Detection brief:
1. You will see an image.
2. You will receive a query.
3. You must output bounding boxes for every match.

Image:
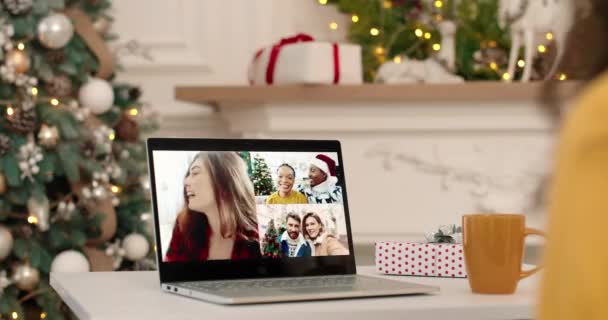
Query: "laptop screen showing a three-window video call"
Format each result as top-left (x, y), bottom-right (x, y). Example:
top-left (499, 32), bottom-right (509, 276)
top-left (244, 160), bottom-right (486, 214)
top-left (151, 148), bottom-right (351, 263)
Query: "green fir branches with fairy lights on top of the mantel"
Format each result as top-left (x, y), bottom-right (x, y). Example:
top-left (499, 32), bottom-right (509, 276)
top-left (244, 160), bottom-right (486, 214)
top-left (326, 0), bottom-right (552, 81)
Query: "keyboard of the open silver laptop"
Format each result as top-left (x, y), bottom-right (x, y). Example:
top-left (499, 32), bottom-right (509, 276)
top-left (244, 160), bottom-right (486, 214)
top-left (176, 276), bottom-right (358, 291)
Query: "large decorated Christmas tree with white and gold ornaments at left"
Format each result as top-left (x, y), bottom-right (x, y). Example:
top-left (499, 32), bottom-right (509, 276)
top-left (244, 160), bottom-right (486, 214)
top-left (0, 0), bottom-right (154, 319)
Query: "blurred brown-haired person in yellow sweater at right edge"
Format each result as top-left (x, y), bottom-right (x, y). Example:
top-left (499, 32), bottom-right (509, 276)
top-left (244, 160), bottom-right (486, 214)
top-left (538, 0), bottom-right (608, 320)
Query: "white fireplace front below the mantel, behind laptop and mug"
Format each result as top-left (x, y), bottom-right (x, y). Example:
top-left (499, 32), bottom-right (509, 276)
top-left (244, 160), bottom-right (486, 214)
top-left (221, 98), bottom-right (553, 243)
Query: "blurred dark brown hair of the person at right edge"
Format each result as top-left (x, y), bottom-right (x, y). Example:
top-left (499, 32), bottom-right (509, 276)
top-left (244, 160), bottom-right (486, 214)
top-left (542, 0), bottom-right (608, 119)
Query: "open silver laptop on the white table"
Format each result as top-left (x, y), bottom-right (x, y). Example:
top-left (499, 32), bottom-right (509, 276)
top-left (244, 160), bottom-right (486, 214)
top-left (147, 138), bottom-right (439, 304)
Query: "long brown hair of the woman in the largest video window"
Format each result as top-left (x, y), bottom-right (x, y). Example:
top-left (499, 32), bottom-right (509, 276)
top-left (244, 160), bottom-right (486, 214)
top-left (178, 152), bottom-right (259, 253)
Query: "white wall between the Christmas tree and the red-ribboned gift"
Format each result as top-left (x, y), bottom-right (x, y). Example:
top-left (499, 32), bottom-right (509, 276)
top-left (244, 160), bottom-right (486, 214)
top-left (113, 0), bottom-right (349, 136)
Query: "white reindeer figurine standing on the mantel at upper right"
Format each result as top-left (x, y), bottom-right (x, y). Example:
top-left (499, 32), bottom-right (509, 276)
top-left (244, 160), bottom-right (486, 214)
top-left (499, 0), bottom-right (578, 82)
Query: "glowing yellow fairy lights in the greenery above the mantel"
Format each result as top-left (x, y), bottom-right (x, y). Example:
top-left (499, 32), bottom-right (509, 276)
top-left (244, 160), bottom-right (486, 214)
top-left (317, 0), bottom-right (568, 81)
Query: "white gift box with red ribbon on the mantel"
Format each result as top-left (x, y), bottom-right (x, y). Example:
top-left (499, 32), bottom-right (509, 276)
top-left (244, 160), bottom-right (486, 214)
top-left (249, 34), bottom-right (363, 85)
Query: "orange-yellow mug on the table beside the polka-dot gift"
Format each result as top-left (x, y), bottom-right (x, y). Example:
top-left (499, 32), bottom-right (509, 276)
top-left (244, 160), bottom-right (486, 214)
top-left (462, 214), bottom-right (545, 294)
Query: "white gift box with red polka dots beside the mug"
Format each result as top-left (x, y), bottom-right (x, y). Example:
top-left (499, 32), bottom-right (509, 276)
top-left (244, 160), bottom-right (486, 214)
top-left (376, 241), bottom-right (467, 278)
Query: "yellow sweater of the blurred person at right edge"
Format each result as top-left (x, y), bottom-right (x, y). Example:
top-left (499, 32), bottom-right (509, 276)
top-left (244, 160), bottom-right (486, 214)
top-left (538, 75), bottom-right (608, 320)
